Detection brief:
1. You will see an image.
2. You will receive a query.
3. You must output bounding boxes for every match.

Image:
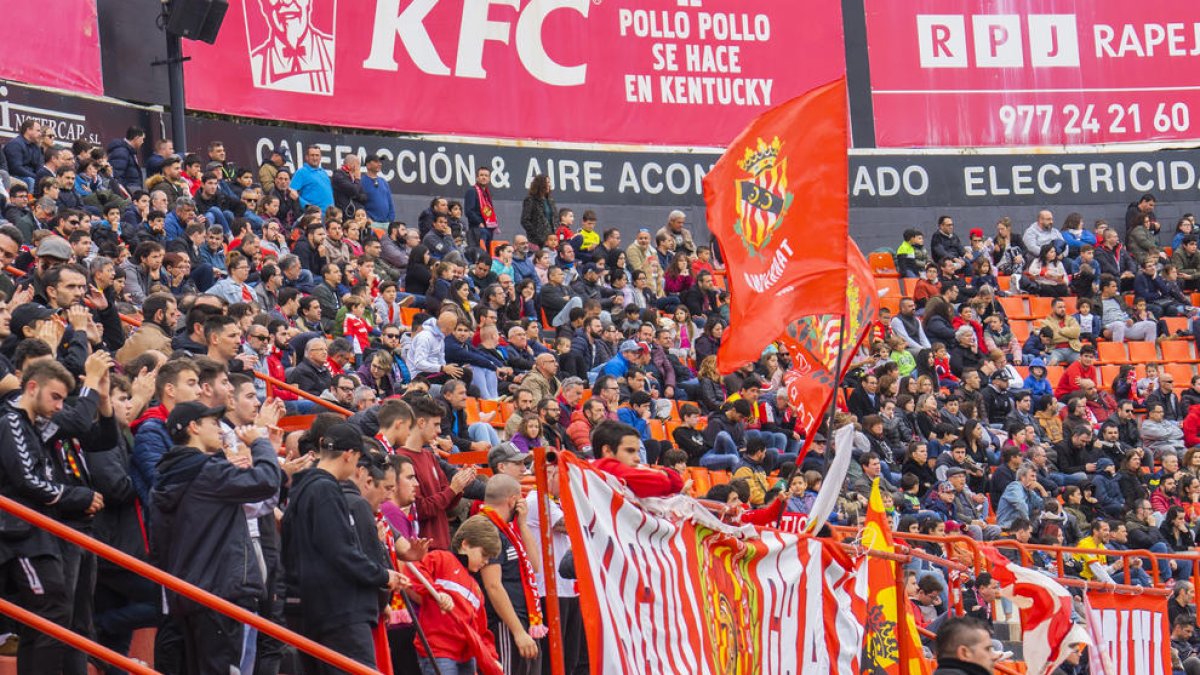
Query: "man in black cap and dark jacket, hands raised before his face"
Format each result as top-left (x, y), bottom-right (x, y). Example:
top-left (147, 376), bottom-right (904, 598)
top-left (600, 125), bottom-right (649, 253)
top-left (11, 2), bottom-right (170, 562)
top-left (150, 401), bottom-right (282, 673)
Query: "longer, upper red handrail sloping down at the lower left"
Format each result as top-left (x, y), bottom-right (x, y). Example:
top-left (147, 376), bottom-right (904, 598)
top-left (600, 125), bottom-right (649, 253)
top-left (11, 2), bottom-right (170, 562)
top-left (0, 487), bottom-right (379, 675)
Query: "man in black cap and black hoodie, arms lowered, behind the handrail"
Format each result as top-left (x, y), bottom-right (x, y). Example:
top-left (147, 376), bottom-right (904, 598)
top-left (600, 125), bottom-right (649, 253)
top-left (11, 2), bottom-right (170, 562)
top-left (282, 423), bottom-right (402, 675)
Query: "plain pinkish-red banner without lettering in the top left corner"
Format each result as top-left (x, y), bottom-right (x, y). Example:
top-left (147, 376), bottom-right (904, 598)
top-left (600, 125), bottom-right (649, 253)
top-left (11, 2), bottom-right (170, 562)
top-left (0, 0), bottom-right (102, 96)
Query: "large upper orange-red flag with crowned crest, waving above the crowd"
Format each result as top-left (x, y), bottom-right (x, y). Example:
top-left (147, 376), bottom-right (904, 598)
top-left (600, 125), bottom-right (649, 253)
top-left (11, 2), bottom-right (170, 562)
top-left (704, 78), bottom-right (850, 372)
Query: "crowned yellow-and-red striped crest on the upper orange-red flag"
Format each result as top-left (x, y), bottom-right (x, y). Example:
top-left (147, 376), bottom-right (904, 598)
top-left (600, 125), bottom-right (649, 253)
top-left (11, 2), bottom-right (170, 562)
top-left (733, 136), bottom-right (792, 256)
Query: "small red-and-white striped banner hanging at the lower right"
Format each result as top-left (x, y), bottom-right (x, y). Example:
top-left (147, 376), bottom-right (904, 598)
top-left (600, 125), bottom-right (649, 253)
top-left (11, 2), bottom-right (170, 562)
top-left (1087, 593), bottom-right (1171, 675)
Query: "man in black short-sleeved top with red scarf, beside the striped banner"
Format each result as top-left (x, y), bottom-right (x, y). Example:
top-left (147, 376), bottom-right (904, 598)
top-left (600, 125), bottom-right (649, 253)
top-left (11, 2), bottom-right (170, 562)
top-left (478, 474), bottom-right (547, 675)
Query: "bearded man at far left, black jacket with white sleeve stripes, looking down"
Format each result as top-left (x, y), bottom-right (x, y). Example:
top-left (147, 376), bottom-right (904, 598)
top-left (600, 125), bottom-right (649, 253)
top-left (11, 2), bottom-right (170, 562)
top-left (0, 359), bottom-right (104, 674)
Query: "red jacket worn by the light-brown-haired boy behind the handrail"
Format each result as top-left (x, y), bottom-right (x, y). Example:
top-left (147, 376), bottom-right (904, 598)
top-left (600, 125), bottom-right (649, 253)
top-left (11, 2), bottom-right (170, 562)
top-left (413, 551), bottom-right (499, 661)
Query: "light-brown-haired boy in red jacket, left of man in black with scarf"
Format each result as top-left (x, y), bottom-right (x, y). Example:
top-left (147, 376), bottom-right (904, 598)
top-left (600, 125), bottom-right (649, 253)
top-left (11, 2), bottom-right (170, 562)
top-left (412, 515), bottom-right (503, 675)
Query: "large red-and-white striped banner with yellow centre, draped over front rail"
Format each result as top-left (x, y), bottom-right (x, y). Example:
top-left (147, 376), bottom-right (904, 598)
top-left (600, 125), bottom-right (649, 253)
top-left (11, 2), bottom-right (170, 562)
top-left (559, 453), bottom-right (863, 675)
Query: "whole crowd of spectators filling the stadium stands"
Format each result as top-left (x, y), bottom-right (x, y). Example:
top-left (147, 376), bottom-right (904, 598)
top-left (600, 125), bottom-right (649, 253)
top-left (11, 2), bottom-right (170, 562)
top-left (0, 121), bottom-right (1200, 674)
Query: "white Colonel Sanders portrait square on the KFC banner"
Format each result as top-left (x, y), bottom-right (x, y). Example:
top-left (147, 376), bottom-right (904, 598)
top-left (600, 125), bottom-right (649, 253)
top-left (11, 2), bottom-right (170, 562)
top-left (242, 0), bottom-right (336, 95)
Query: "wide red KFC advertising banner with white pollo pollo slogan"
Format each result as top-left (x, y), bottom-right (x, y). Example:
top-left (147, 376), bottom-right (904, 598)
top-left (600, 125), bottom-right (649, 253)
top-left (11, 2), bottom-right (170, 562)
top-left (186, 0), bottom-right (845, 147)
